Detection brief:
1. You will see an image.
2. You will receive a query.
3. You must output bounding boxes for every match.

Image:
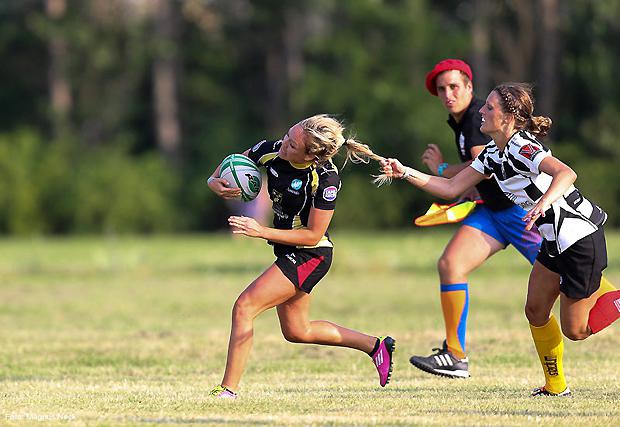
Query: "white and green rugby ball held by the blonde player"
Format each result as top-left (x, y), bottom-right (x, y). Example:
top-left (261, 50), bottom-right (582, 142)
top-left (220, 154), bottom-right (262, 202)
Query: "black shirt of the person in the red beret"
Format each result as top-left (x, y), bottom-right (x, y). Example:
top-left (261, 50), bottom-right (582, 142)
top-left (448, 98), bottom-right (512, 211)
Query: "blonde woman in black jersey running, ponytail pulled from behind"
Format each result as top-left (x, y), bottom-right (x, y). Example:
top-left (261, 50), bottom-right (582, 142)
top-left (209, 115), bottom-right (395, 399)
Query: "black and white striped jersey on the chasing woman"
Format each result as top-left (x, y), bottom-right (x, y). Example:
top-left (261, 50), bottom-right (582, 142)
top-left (471, 131), bottom-right (607, 255)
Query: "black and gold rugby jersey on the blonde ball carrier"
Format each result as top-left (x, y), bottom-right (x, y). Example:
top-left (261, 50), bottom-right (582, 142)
top-left (248, 140), bottom-right (340, 254)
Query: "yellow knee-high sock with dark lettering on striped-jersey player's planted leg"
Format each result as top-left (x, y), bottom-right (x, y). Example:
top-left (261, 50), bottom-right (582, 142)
top-left (530, 314), bottom-right (566, 393)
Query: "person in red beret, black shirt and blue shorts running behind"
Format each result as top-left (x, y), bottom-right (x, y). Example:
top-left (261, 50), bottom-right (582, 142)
top-left (409, 59), bottom-right (615, 378)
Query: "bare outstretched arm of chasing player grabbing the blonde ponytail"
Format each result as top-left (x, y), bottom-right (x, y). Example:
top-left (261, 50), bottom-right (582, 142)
top-left (381, 159), bottom-right (486, 199)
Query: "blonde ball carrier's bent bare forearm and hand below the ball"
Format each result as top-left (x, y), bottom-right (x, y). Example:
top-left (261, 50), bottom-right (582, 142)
top-left (228, 208), bottom-right (334, 246)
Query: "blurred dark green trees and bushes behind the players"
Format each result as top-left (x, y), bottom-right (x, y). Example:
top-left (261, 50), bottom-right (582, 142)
top-left (0, 0), bottom-right (620, 234)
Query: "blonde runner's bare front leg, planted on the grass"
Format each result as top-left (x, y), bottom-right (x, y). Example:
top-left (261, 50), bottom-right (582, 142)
top-left (222, 264), bottom-right (297, 390)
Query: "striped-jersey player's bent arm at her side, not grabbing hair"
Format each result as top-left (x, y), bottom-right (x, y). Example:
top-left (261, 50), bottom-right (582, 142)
top-left (523, 157), bottom-right (577, 230)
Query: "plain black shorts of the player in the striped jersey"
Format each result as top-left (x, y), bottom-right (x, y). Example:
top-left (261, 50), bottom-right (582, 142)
top-left (536, 227), bottom-right (607, 299)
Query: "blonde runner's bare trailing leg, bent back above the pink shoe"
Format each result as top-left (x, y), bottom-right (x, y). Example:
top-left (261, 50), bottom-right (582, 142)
top-left (277, 290), bottom-right (377, 353)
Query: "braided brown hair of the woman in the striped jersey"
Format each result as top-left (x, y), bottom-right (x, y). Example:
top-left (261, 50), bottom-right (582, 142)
top-left (493, 83), bottom-right (553, 138)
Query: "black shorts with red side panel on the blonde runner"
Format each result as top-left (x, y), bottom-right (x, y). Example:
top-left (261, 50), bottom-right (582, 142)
top-left (275, 248), bottom-right (333, 294)
